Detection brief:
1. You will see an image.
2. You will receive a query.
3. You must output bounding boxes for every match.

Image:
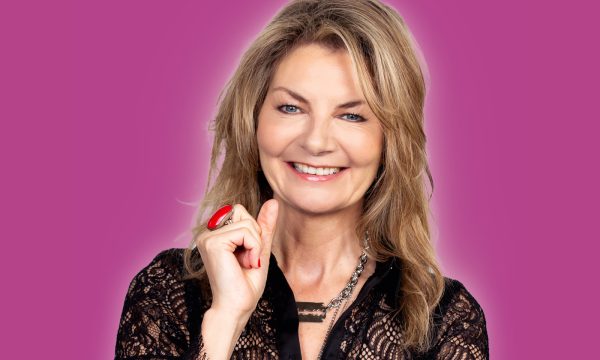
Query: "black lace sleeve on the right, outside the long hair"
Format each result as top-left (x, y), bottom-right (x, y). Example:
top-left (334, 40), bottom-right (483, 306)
top-left (433, 279), bottom-right (489, 360)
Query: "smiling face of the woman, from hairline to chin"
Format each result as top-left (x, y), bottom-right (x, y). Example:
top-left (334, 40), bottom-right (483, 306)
top-left (257, 44), bottom-right (383, 214)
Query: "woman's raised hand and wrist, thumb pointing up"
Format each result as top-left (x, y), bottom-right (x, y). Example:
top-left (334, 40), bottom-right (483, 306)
top-left (196, 199), bottom-right (278, 325)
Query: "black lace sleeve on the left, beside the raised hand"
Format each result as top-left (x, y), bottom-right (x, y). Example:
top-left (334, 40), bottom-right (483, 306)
top-left (115, 249), bottom-right (206, 360)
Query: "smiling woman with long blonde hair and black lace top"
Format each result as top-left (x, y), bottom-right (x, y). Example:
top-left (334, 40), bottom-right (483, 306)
top-left (116, 0), bottom-right (488, 359)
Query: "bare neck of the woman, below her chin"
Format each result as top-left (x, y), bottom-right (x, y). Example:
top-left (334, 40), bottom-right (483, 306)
top-left (272, 199), bottom-right (363, 284)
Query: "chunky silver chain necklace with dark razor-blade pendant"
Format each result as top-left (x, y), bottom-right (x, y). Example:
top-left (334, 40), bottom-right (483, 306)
top-left (296, 243), bottom-right (368, 322)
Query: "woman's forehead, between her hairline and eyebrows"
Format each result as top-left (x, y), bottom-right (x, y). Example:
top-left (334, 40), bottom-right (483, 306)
top-left (270, 44), bottom-right (363, 98)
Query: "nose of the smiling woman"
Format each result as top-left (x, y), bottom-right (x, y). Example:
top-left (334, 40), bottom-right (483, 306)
top-left (300, 116), bottom-right (335, 156)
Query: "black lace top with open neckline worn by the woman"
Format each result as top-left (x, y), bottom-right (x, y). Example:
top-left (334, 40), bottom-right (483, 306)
top-left (115, 249), bottom-right (489, 360)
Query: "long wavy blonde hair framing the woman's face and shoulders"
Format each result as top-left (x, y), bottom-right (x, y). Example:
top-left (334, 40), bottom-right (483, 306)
top-left (185, 0), bottom-right (444, 350)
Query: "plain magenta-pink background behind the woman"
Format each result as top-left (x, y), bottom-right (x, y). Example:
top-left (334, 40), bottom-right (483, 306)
top-left (0, 0), bottom-right (600, 359)
